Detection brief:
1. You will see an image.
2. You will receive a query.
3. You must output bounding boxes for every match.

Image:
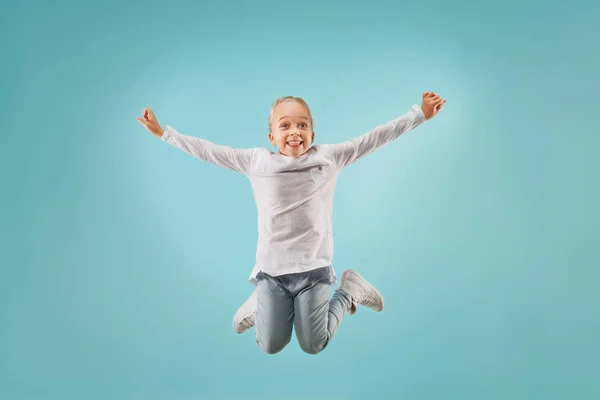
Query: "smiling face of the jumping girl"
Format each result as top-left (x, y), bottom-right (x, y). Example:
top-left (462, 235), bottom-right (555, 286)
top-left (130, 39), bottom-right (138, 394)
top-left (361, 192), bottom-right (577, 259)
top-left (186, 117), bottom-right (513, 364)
top-left (269, 101), bottom-right (315, 157)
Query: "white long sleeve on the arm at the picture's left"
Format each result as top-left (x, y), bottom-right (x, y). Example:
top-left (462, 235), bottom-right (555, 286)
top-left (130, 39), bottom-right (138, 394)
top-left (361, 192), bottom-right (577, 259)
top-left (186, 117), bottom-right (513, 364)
top-left (160, 125), bottom-right (255, 175)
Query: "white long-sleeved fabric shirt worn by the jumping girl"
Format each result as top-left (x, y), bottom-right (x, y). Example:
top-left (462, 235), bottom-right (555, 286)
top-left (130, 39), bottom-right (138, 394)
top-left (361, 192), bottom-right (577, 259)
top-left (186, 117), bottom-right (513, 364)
top-left (161, 104), bottom-right (425, 284)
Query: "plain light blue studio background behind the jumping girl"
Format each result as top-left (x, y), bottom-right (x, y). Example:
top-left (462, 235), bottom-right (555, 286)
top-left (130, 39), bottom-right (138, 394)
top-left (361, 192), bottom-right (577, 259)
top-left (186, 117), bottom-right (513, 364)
top-left (0, 0), bottom-right (600, 400)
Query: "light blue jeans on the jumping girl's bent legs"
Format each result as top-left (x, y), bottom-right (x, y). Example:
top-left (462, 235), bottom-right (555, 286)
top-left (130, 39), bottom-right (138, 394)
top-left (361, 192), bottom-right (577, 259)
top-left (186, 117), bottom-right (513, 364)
top-left (255, 268), bottom-right (351, 354)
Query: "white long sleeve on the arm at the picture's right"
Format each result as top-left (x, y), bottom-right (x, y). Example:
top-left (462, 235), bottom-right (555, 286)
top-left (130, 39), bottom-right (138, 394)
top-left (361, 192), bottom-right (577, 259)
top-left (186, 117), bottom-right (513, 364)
top-left (323, 104), bottom-right (425, 168)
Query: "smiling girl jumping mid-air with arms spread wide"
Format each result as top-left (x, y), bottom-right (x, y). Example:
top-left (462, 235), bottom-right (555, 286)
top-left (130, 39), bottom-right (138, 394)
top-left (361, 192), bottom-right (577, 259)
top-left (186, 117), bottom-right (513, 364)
top-left (137, 92), bottom-right (446, 354)
